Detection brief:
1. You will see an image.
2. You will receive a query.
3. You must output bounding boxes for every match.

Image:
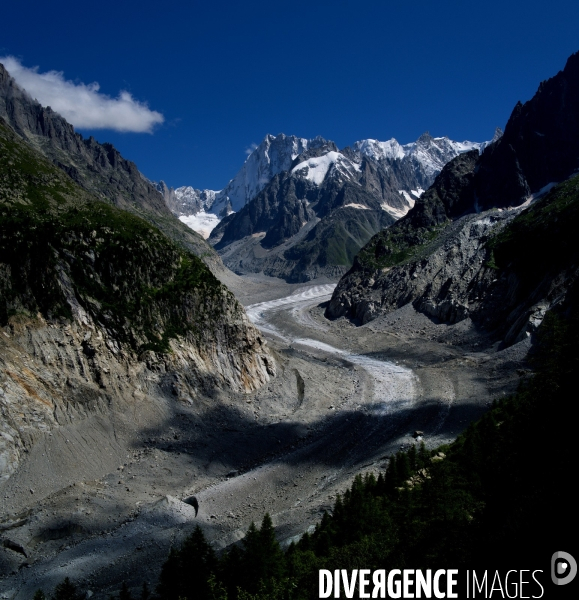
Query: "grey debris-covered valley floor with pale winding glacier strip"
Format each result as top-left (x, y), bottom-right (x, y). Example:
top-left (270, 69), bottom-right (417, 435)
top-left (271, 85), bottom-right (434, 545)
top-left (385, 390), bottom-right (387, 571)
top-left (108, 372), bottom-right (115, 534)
top-left (0, 275), bottom-right (528, 599)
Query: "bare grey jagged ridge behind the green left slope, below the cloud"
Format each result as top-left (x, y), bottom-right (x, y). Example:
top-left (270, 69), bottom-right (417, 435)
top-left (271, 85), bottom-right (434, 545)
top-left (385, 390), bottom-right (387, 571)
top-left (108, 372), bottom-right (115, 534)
top-left (0, 59), bottom-right (223, 274)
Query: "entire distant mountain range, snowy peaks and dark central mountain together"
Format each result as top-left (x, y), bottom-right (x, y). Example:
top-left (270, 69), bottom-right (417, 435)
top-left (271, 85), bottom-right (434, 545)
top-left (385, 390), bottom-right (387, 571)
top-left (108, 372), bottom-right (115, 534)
top-left (157, 130), bottom-right (494, 281)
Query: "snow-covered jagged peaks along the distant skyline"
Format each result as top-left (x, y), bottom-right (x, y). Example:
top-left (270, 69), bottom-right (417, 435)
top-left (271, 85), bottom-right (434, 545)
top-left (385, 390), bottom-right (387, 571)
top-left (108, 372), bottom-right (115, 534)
top-left (159, 132), bottom-right (498, 235)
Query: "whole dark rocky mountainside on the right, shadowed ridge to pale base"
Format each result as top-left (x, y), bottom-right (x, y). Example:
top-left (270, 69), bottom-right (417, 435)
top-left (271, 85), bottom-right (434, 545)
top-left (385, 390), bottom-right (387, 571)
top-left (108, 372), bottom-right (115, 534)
top-left (326, 54), bottom-right (579, 345)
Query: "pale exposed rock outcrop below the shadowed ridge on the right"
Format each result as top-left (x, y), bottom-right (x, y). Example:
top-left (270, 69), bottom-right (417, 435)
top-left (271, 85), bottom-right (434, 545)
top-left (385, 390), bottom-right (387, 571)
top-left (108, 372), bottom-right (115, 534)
top-left (327, 177), bottom-right (579, 346)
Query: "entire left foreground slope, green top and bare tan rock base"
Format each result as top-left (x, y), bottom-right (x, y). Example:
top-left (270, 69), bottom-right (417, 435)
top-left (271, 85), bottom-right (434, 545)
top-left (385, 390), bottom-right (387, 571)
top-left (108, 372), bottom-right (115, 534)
top-left (0, 121), bottom-right (275, 478)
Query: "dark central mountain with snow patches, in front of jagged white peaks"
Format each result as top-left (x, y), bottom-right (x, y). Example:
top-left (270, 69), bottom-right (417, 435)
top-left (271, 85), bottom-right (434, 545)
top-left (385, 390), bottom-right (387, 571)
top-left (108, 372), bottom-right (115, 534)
top-left (210, 134), bottom-right (481, 281)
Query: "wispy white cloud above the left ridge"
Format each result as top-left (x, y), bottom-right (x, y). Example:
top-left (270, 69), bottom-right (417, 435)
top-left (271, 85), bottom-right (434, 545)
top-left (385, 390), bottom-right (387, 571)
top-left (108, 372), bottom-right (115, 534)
top-left (0, 56), bottom-right (165, 133)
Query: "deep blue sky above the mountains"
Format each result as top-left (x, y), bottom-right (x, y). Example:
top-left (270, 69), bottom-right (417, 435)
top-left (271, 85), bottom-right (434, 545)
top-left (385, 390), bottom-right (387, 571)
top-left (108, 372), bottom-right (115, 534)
top-left (0, 0), bottom-right (579, 189)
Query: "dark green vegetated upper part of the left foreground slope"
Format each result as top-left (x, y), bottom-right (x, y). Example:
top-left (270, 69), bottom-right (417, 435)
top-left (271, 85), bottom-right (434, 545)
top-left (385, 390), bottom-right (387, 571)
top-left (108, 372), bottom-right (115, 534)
top-left (0, 118), bottom-right (227, 352)
